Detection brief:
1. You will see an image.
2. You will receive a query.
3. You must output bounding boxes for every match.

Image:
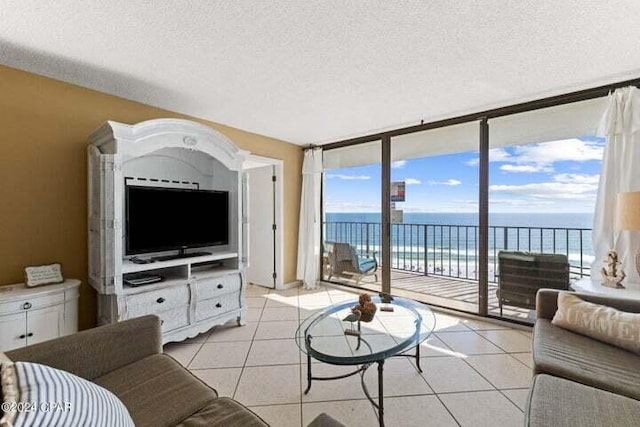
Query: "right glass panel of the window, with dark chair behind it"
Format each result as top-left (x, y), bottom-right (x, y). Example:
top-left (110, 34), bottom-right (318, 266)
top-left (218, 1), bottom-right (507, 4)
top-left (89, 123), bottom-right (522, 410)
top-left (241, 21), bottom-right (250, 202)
top-left (488, 98), bottom-right (606, 322)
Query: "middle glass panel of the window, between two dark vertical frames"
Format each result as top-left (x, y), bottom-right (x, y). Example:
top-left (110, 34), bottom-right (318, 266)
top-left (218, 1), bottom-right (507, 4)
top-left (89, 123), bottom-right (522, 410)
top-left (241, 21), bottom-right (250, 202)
top-left (390, 121), bottom-right (479, 313)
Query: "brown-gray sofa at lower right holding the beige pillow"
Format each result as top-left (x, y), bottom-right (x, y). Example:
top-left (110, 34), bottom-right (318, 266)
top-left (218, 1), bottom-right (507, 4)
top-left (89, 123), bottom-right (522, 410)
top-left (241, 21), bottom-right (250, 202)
top-left (525, 289), bottom-right (640, 427)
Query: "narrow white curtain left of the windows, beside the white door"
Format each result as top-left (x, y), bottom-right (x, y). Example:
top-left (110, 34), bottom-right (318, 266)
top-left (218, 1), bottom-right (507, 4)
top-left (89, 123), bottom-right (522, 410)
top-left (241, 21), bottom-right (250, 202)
top-left (296, 148), bottom-right (322, 289)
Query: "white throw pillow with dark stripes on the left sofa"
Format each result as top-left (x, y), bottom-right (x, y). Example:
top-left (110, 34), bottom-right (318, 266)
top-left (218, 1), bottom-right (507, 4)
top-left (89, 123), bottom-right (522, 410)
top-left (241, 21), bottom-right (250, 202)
top-left (0, 362), bottom-right (134, 427)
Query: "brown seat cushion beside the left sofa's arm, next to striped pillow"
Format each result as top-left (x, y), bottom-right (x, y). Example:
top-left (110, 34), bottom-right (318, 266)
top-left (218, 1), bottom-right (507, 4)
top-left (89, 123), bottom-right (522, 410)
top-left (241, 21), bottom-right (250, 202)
top-left (94, 354), bottom-right (217, 427)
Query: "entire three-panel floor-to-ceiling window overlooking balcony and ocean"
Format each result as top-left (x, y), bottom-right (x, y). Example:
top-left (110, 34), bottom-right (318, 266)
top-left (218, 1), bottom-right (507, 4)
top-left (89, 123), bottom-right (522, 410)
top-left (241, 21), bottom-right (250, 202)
top-left (323, 83), bottom-right (628, 322)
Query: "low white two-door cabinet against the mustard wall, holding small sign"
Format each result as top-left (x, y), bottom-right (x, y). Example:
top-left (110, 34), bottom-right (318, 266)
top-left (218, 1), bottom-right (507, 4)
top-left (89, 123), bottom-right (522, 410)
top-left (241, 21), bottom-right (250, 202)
top-left (0, 279), bottom-right (80, 351)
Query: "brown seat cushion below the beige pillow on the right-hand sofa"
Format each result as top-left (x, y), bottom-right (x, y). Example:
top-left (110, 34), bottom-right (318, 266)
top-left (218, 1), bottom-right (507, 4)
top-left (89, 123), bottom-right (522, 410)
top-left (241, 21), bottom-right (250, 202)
top-left (533, 319), bottom-right (640, 399)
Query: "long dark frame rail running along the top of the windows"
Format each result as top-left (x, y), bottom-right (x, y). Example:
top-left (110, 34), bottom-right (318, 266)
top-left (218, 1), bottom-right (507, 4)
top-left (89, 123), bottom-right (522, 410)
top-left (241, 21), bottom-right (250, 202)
top-left (320, 78), bottom-right (640, 150)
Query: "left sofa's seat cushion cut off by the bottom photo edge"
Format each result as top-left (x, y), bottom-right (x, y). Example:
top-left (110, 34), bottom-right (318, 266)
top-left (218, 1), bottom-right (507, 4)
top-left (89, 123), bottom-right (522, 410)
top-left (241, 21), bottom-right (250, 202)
top-left (177, 397), bottom-right (268, 427)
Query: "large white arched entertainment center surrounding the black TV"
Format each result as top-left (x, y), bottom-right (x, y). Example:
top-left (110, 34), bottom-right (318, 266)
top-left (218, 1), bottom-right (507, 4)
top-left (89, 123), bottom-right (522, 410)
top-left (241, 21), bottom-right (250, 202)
top-left (88, 119), bottom-right (248, 343)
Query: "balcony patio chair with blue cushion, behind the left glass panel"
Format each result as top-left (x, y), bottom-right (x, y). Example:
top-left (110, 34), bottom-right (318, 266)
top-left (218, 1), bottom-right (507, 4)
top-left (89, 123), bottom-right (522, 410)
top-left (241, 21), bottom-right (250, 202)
top-left (325, 242), bottom-right (378, 284)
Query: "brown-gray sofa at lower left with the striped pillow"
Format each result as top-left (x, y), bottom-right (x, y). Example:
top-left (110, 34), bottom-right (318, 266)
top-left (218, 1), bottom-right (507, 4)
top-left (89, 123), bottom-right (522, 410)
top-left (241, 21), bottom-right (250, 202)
top-left (7, 316), bottom-right (342, 427)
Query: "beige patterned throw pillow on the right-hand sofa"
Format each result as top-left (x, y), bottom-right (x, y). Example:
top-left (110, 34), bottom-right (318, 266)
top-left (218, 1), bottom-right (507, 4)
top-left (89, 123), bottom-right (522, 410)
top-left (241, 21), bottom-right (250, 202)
top-left (551, 292), bottom-right (640, 354)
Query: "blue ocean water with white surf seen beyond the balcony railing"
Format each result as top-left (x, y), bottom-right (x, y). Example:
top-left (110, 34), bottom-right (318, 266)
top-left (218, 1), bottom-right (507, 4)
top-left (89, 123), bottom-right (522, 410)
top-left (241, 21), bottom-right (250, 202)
top-left (324, 213), bottom-right (594, 280)
